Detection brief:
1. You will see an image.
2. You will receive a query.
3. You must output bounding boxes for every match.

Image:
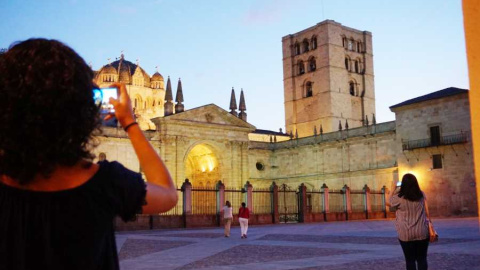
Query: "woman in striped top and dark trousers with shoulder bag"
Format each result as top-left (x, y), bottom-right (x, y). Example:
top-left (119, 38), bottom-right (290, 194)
top-left (390, 174), bottom-right (435, 270)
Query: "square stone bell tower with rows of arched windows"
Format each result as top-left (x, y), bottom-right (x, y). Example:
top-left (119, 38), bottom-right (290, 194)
top-left (282, 20), bottom-right (375, 137)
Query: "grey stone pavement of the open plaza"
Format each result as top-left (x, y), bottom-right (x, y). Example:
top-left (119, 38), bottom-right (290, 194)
top-left (116, 218), bottom-right (480, 270)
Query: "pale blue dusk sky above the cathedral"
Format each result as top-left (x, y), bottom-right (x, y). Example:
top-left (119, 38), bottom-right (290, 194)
top-left (0, 0), bottom-right (468, 130)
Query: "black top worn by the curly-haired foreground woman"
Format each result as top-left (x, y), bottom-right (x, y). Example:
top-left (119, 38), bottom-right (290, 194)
top-left (0, 161), bottom-right (146, 270)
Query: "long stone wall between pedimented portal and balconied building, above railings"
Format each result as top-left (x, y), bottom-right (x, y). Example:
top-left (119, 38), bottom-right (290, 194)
top-left (249, 122), bottom-right (398, 190)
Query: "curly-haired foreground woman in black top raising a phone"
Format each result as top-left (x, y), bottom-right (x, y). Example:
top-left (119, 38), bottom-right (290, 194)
top-left (0, 39), bottom-right (177, 269)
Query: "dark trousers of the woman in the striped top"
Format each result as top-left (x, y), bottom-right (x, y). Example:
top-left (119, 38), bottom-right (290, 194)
top-left (398, 238), bottom-right (429, 270)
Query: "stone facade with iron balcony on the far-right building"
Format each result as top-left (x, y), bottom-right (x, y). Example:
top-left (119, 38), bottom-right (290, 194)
top-left (392, 91), bottom-right (477, 215)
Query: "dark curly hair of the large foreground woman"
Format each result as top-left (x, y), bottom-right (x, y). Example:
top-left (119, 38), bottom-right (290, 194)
top-left (0, 39), bottom-right (101, 184)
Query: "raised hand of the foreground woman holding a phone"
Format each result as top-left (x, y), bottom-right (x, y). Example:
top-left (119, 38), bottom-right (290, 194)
top-left (105, 83), bottom-right (135, 127)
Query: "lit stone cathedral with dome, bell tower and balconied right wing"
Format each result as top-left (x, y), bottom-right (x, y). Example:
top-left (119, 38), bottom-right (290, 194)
top-left (95, 20), bottom-right (477, 215)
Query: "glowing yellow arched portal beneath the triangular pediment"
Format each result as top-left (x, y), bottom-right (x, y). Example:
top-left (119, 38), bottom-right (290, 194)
top-left (185, 143), bottom-right (222, 187)
